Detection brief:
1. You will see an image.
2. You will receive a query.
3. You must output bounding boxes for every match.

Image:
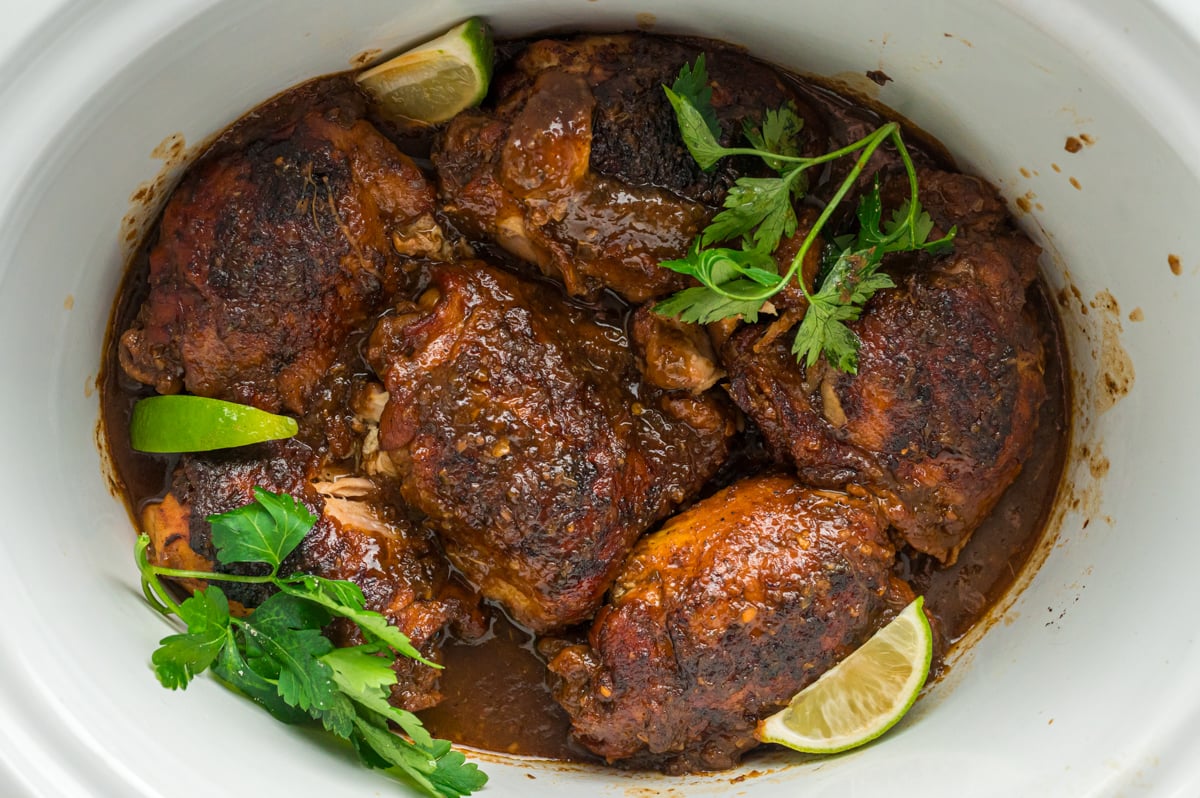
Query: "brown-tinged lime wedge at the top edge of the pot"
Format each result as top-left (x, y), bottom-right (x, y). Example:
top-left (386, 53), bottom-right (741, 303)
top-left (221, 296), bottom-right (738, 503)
top-left (358, 17), bottom-right (492, 124)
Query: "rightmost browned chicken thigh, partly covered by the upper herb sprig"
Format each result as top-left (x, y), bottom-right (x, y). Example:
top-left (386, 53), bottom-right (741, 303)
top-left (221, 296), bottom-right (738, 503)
top-left (722, 170), bottom-right (1045, 564)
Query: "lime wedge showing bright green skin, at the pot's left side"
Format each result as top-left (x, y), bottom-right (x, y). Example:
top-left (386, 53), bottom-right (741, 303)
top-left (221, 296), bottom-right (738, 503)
top-left (130, 395), bottom-right (299, 452)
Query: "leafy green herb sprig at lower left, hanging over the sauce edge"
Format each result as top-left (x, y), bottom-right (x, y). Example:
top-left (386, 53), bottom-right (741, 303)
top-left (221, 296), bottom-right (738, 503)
top-left (134, 487), bottom-right (487, 798)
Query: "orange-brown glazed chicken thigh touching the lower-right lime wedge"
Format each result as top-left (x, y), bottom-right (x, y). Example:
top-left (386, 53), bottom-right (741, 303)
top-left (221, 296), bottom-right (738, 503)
top-left (542, 474), bottom-right (912, 773)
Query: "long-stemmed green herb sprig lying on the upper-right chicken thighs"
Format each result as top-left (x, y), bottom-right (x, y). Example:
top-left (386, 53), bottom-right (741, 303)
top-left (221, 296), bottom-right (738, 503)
top-left (654, 55), bottom-right (956, 373)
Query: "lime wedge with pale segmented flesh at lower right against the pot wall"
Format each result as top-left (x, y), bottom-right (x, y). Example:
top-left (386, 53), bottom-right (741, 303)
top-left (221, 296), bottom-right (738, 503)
top-left (756, 598), bottom-right (934, 754)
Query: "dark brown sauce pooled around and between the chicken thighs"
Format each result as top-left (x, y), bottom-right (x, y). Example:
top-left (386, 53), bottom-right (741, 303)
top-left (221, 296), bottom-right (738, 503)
top-left (102, 35), bottom-right (1069, 761)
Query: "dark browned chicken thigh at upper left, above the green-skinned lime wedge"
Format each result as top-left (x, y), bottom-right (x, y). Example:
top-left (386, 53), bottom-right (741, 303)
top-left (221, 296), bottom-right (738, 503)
top-left (119, 94), bottom-right (444, 414)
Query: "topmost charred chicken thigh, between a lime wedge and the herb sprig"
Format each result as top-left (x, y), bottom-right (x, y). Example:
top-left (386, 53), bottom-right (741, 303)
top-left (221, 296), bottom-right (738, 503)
top-left (433, 35), bottom-right (820, 302)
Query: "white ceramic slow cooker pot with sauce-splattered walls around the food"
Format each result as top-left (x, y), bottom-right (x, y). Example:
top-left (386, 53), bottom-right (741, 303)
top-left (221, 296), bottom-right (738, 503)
top-left (0, 0), bottom-right (1200, 798)
